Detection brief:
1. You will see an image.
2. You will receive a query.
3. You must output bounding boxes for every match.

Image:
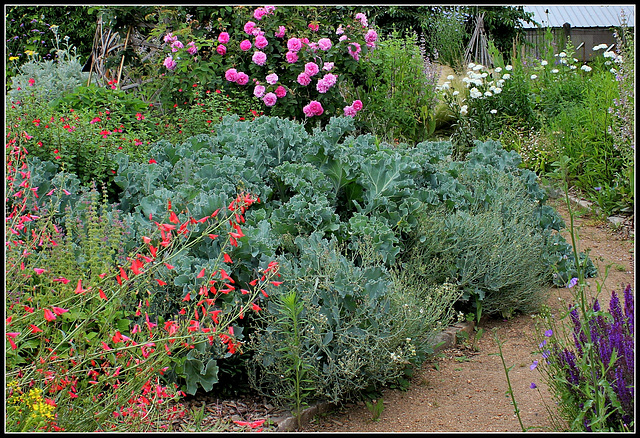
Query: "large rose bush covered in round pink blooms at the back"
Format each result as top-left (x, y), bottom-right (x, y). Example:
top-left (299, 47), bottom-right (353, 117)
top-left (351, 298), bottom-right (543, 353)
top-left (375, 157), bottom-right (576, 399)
top-left (163, 6), bottom-right (378, 122)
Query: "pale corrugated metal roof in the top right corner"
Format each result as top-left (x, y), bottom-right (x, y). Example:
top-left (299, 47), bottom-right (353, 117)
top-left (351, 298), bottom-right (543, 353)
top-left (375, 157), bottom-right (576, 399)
top-left (523, 5), bottom-right (636, 29)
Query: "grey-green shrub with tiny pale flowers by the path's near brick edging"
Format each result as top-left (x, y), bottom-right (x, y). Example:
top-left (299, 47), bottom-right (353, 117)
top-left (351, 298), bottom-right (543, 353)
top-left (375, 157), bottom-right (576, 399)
top-left (250, 233), bottom-right (460, 402)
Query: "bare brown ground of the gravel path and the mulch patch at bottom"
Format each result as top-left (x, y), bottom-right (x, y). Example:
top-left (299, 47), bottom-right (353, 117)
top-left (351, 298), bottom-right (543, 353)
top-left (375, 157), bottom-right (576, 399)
top-left (173, 200), bottom-right (635, 432)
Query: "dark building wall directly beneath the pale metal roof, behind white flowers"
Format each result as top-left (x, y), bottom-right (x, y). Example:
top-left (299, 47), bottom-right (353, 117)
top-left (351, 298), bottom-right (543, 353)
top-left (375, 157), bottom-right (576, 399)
top-left (522, 27), bottom-right (632, 62)
